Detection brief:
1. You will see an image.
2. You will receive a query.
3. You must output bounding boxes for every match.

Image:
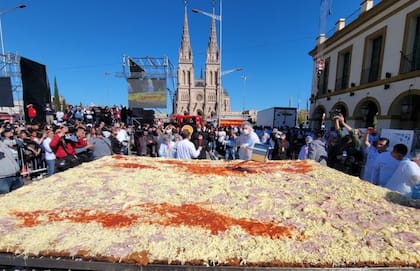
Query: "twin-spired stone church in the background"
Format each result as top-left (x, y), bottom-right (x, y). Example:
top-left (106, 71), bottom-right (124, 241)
top-left (173, 3), bottom-right (230, 120)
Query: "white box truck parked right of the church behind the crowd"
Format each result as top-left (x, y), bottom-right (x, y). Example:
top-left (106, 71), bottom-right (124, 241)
top-left (257, 107), bottom-right (297, 128)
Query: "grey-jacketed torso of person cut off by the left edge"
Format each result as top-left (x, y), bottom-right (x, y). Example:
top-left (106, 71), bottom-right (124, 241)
top-left (0, 141), bottom-right (23, 194)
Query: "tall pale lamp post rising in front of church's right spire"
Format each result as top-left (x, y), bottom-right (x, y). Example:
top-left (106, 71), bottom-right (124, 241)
top-left (192, 0), bottom-right (223, 125)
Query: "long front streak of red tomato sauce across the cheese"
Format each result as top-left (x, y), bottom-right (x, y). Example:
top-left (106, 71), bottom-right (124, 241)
top-left (13, 203), bottom-right (294, 239)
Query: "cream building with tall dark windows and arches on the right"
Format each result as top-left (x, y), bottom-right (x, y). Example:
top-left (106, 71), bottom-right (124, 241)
top-left (310, 0), bottom-right (420, 130)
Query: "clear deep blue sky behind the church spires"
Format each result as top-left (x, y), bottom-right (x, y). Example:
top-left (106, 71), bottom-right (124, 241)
top-left (0, 0), bottom-right (366, 113)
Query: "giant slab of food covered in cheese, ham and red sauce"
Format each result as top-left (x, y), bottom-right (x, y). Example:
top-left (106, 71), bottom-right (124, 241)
top-left (0, 156), bottom-right (420, 266)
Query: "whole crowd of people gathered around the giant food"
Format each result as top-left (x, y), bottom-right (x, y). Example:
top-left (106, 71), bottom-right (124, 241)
top-left (0, 105), bottom-right (420, 201)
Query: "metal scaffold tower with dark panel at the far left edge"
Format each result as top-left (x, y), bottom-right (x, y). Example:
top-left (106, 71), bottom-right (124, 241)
top-left (0, 53), bottom-right (24, 119)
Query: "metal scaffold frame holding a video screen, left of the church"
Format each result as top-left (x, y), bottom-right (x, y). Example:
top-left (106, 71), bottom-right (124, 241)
top-left (123, 56), bottom-right (176, 109)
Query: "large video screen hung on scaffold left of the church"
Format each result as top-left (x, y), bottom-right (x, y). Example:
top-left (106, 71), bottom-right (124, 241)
top-left (127, 78), bottom-right (167, 108)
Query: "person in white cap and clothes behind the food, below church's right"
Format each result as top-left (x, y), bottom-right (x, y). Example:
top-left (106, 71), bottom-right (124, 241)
top-left (236, 121), bottom-right (260, 160)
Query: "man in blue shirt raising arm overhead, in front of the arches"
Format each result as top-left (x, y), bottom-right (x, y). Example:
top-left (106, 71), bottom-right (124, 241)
top-left (361, 127), bottom-right (389, 183)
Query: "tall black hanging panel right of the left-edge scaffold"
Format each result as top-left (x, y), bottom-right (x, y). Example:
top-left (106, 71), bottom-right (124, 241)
top-left (20, 57), bottom-right (51, 122)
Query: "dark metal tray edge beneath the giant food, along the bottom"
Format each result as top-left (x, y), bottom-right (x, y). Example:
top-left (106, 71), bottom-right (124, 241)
top-left (0, 253), bottom-right (420, 271)
